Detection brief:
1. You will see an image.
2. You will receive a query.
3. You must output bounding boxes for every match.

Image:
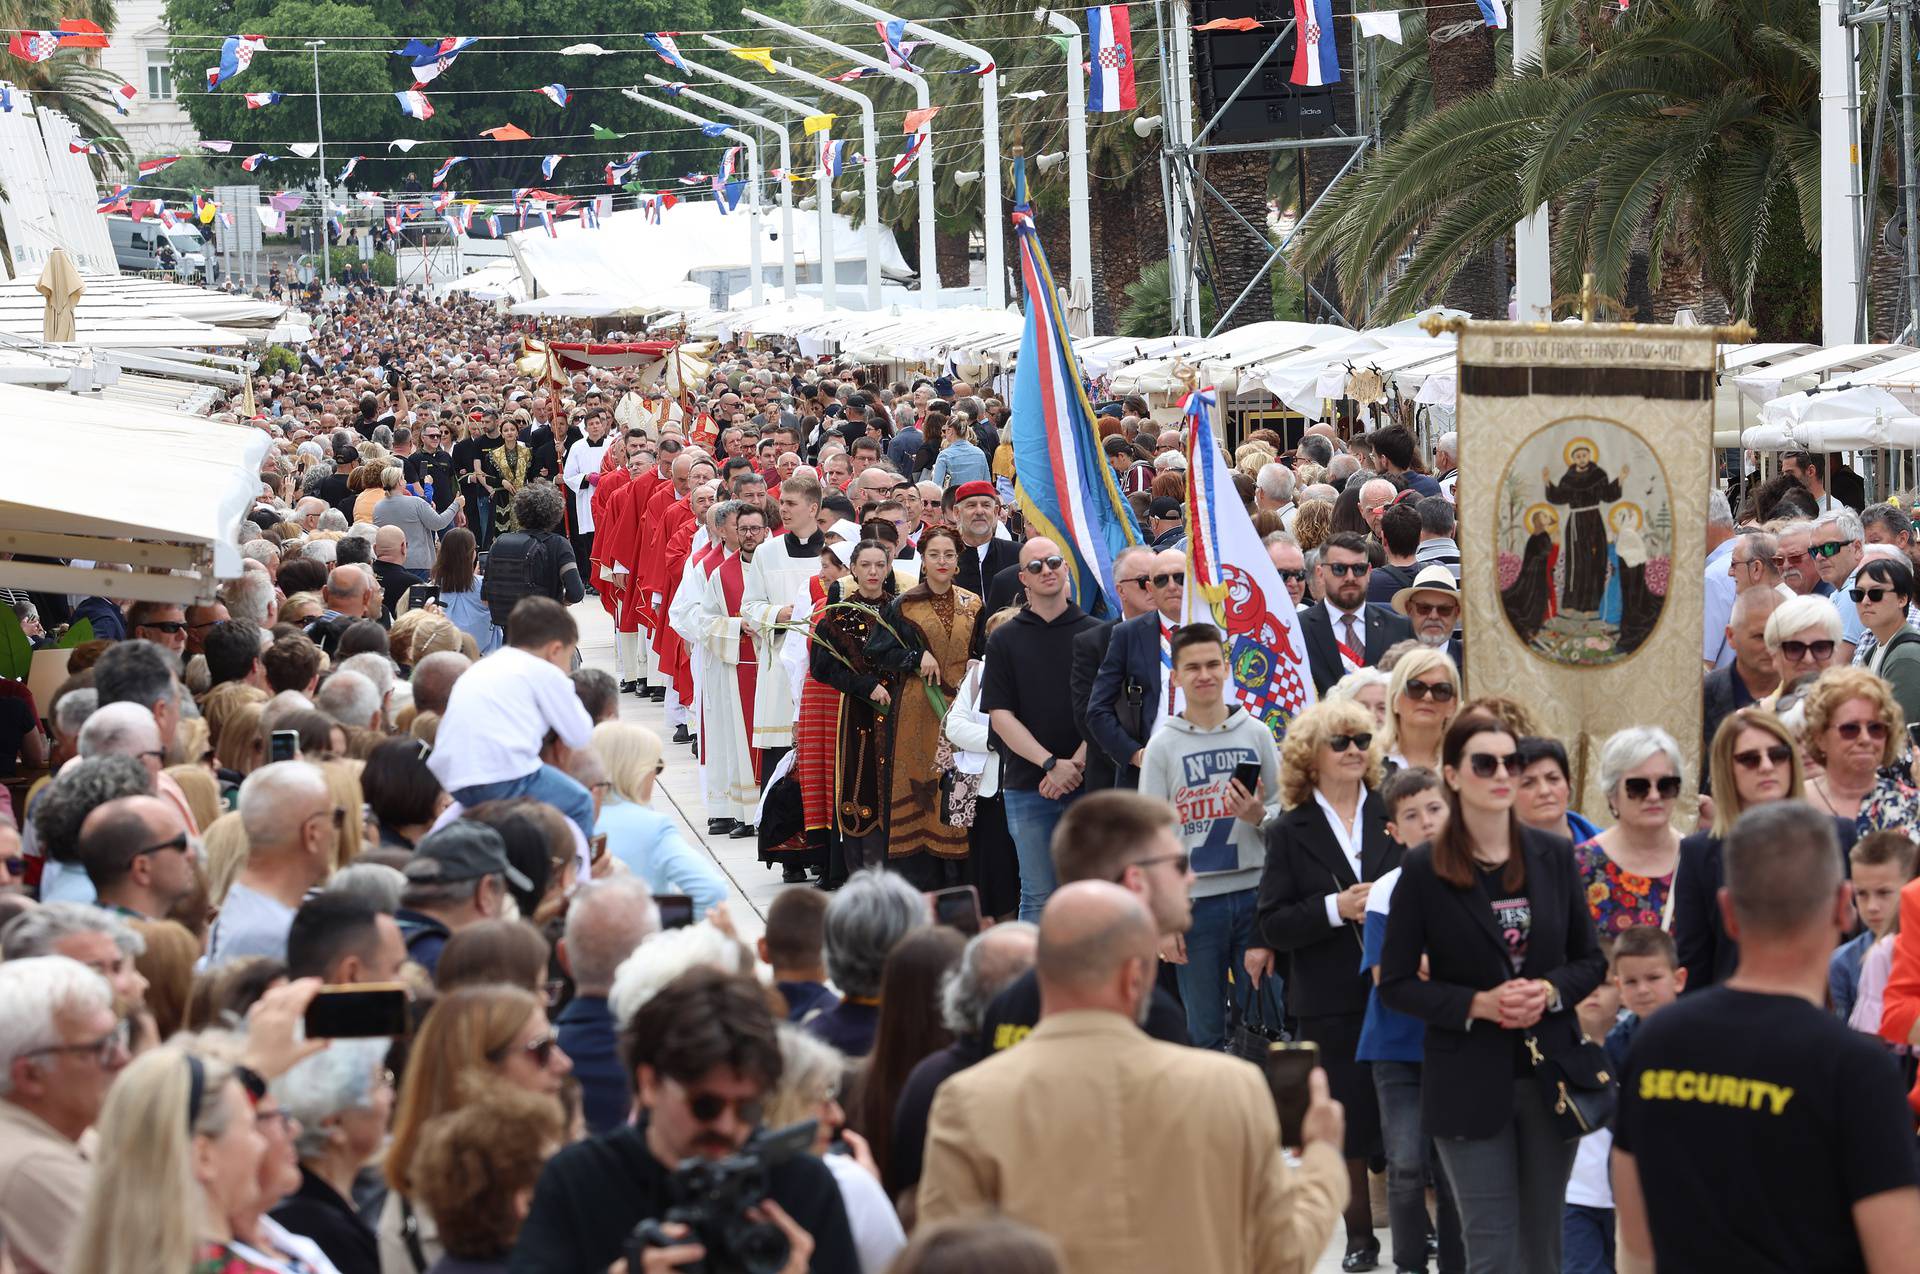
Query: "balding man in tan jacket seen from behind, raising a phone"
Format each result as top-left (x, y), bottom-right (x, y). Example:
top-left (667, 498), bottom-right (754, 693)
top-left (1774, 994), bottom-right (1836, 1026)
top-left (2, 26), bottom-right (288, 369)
top-left (920, 881), bottom-right (1348, 1274)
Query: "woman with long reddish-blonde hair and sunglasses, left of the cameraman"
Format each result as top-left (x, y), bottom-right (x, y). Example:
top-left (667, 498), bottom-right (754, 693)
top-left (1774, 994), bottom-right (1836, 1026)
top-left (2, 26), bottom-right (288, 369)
top-left (376, 986), bottom-right (572, 1274)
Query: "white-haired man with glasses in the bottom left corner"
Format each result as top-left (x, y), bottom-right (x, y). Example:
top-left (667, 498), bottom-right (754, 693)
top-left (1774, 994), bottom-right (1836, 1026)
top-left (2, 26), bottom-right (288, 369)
top-left (0, 956), bottom-right (129, 1272)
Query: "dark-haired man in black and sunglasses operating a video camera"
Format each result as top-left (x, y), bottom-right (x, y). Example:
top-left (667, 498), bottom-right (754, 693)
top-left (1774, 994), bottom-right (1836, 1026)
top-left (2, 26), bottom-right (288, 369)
top-left (507, 969), bottom-right (860, 1274)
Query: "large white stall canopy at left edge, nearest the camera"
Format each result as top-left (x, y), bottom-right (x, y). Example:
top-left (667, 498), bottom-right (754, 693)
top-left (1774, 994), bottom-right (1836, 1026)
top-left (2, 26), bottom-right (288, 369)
top-left (0, 384), bottom-right (269, 604)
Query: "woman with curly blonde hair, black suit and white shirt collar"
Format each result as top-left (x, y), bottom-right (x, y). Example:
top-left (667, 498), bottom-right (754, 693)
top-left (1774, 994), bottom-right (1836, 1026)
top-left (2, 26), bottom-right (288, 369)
top-left (1258, 700), bottom-right (1400, 1270)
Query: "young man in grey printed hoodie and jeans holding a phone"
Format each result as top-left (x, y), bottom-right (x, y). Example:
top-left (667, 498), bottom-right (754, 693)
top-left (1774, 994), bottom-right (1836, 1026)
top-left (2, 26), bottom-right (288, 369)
top-left (1140, 624), bottom-right (1281, 1048)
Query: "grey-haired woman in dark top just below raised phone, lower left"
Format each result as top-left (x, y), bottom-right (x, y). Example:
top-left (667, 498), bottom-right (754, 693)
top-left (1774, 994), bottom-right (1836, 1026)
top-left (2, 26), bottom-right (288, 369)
top-left (269, 1040), bottom-right (394, 1274)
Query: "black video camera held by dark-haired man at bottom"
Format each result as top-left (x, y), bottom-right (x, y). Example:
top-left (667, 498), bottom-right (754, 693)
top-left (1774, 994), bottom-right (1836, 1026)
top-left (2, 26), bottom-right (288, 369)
top-left (626, 1119), bottom-right (820, 1274)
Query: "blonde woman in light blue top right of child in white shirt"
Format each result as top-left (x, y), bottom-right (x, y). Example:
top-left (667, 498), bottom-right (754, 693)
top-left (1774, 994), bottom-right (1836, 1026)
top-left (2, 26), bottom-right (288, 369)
top-left (591, 721), bottom-right (726, 915)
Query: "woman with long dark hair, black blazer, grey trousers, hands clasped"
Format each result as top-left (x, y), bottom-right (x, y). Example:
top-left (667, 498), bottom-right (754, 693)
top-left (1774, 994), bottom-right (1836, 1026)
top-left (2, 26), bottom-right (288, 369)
top-left (1380, 712), bottom-right (1607, 1274)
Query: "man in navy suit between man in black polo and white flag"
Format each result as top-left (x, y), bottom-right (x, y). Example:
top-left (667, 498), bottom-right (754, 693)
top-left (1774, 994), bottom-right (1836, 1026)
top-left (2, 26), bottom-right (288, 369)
top-left (1087, 549), bottom-right (1187, 787)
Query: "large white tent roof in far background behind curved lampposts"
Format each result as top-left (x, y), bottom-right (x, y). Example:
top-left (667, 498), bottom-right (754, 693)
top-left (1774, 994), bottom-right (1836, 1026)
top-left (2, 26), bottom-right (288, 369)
top-left (507, 201), bottom-right (912, 305)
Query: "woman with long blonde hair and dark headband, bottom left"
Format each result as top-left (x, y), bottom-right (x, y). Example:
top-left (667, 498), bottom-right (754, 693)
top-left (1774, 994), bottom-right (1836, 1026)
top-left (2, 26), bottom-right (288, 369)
top-left (67, 1048), bottom-right (267, 1274)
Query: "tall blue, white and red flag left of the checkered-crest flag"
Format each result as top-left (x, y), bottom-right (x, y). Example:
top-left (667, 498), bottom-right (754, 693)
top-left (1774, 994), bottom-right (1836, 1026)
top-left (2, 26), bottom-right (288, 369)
top-left (1010, 159), bottom-right (1142, 616)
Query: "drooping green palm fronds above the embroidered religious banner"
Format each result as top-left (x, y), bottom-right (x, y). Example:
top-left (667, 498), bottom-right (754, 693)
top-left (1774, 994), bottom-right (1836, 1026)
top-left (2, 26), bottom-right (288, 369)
top-left (1298, 0), bottom-right (1820, 319)
